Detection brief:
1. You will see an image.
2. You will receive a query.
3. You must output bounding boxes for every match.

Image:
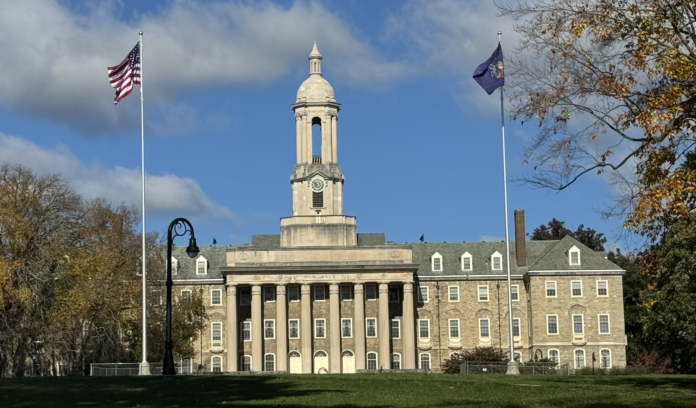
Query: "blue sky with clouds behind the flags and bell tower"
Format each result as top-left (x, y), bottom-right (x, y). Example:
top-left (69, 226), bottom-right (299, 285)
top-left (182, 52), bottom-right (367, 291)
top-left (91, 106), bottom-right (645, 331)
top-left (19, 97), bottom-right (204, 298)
top-left (0, 0), bottom-right (620, 249)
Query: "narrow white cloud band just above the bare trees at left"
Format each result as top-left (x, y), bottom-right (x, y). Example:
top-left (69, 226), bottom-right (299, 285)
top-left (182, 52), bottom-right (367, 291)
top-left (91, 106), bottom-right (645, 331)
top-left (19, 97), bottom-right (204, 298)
top-left (0, 133), bottom-right (233, 219)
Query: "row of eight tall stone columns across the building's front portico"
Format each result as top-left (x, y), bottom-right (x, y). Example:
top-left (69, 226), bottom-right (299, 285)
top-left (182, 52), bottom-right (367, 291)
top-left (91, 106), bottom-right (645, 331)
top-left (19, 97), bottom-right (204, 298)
top-left (226, 282), bottom-right (416, 373)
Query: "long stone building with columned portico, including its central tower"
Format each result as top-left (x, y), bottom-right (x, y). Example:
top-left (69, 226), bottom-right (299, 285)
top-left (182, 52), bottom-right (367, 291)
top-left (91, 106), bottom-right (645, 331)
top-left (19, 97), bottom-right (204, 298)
top-left (172, 44), bottom-right (626, 373)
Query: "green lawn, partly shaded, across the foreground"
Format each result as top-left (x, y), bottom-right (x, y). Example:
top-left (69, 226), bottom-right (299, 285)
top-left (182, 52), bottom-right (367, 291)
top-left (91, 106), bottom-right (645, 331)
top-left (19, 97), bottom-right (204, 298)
top-left (0, 373), bottom-right (696, 408)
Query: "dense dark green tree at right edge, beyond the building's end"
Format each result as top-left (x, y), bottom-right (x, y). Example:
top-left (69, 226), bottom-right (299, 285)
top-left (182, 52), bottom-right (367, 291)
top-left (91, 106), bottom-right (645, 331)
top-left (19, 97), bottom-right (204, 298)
top-left (641, 214), bottom-right (696, 373)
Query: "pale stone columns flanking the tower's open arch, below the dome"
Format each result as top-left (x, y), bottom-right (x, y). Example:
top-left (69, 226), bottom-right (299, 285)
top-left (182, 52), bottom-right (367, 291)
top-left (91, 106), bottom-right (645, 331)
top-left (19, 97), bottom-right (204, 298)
top-left (295, 113), bottom-right (338, 164)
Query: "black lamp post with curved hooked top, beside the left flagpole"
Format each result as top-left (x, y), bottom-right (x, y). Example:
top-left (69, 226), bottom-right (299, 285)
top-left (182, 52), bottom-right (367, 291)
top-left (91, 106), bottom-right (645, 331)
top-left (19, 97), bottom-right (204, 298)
top-left (162, 218), bottom-right (200, 375)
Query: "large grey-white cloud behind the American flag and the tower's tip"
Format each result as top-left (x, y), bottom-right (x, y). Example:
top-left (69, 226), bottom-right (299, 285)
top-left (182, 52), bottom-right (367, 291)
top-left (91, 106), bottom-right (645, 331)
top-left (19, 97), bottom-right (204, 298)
top-left (0, 0), bottom-right (405, 134)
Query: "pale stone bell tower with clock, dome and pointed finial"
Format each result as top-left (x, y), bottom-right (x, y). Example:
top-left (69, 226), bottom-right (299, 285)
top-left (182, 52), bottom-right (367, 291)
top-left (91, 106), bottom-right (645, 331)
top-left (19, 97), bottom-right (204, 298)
top-left (281, 42), bottom-right (357, 246)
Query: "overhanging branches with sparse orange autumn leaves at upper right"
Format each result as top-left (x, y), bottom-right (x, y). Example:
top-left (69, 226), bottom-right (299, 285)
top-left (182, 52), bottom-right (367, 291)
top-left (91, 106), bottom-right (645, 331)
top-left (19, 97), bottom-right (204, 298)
top-left (499, 0), bottom-right (696, 242)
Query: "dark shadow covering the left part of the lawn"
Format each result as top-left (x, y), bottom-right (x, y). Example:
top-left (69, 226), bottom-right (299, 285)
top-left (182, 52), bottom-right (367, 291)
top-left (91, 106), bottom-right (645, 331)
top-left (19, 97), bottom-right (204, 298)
top-left (0, 375), bottom-right (377, 408)
